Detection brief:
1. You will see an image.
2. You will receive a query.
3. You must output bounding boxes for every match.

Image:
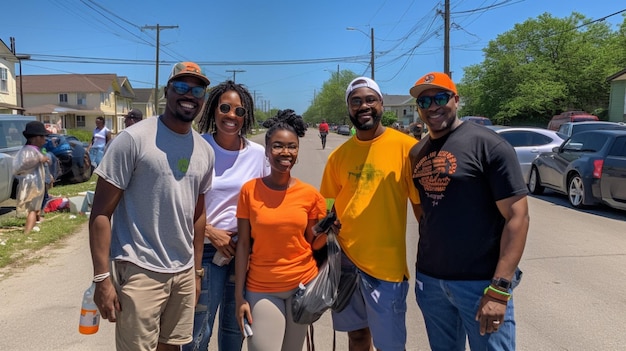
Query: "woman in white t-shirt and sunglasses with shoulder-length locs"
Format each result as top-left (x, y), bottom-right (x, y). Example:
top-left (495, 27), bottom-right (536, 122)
top-left (183, 80), bottom-right (270, 351)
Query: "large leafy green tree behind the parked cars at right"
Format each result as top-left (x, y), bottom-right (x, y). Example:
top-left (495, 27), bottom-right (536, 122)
top-left (458, 12), bottom-right (626, 125)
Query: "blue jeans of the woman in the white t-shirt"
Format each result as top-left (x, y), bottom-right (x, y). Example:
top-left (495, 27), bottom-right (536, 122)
top-left (183, 244), bottom-right (243, 351)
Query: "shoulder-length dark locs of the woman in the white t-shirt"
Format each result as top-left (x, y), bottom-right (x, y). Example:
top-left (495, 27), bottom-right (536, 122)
top-left (198, 80), bottom-right (254, 136)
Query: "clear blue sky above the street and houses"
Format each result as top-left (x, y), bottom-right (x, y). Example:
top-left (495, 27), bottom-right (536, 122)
top-left (0, 0), bottom-right (626, 113)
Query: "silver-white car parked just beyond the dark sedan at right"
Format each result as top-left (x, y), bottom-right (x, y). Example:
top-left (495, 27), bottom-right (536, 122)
top-left (490, 127), bottom-right (566, 184)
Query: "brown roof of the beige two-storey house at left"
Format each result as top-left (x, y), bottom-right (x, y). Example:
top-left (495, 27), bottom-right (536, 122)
top-left (18, 73), bottom-right (119, 94)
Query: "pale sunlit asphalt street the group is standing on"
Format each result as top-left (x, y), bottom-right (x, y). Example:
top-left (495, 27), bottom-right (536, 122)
top-left (0, 130), bottom-right (626, 351)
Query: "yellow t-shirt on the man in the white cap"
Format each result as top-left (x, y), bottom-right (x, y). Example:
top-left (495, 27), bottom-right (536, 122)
top-left (321, 128), bottom-right (419, 282)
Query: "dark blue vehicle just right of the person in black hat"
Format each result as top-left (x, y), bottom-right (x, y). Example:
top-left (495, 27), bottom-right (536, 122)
top-left (43, 134), bottom-right (92, 183)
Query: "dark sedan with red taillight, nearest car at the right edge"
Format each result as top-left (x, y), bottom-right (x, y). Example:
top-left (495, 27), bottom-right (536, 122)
top-left (528, 129), bottom-right (626, 210)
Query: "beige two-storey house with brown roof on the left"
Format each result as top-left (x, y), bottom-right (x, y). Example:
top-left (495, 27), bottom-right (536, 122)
top-left (18, 74), bottom-right (142, 133)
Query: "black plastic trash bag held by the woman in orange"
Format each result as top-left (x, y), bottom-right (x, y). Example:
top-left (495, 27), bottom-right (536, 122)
top-left (291, 228), bottom-right (341, 324)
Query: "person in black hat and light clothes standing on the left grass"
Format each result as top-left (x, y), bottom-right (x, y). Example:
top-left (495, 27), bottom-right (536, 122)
top-left (13, 121), bottom-right (50, 234)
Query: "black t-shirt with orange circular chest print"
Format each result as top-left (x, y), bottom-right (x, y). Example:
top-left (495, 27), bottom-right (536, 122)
top-left (411, 123), bottom-right (527, 280)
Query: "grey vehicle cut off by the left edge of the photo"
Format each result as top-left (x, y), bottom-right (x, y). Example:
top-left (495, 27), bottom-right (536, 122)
top-left (0, 114), bottom-right (35, 202)
